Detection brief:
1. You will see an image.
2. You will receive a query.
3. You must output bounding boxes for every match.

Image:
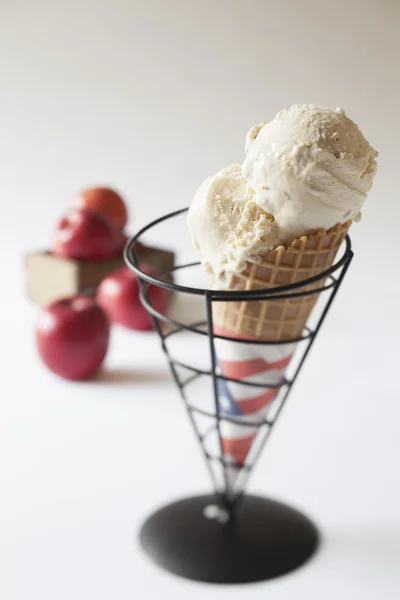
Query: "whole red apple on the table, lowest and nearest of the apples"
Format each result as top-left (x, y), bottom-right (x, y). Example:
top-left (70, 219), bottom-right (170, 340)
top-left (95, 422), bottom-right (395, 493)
top-left (36, 295), bottom-right (110, 379)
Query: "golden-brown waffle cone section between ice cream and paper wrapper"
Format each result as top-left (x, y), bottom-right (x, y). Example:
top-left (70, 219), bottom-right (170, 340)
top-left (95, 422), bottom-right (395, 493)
top-left (213, 220), bottom-right (352, 341)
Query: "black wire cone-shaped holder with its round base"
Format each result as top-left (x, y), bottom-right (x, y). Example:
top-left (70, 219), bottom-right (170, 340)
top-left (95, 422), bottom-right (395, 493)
top-left (125, 208), bottom-right (353, 583)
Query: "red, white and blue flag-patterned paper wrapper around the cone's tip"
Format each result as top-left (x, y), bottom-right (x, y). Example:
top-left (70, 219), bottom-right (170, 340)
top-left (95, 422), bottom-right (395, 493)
top-left (214, 326), bottom-right (297, 491)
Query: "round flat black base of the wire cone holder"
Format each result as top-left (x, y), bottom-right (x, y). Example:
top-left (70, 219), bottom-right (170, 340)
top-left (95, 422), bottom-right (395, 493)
top-left (140, 495), bottom-right (318, 583)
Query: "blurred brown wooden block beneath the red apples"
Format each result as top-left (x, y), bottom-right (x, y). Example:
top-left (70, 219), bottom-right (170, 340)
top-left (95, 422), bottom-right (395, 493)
top-left (25, 247), bottom-right (175, 306)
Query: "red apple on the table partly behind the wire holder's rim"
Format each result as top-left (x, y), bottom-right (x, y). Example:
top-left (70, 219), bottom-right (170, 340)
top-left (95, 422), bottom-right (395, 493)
top-left (96, 265), bottom-right (170, 330)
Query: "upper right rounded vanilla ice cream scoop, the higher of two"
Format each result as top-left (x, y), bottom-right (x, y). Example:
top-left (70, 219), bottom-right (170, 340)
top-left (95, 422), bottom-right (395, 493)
top-left (242, 104), bottom-right (377, 240)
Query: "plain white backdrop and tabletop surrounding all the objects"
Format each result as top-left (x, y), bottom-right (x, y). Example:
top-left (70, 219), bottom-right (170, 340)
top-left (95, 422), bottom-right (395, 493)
top-left (0, 0), bottom-right (400, 600)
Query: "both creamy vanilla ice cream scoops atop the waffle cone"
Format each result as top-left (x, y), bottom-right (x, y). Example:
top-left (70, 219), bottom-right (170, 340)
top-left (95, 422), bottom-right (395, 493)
top-left (188, 104), bottom-right (377, 285)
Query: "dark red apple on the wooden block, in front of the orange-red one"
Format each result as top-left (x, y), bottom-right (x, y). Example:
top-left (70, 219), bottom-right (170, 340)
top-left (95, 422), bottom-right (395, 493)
top-left (51, 208), bottom-right (123, 260)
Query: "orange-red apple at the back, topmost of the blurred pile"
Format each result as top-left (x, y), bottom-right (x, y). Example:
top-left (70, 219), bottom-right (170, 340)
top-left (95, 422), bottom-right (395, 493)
top-left (72, 187), bottom-right (128, 229)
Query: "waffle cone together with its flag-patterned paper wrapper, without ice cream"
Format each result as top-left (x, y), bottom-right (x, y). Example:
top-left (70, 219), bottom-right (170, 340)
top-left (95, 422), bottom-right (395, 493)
top-left (213, 221), bottom-right (351, 492)
